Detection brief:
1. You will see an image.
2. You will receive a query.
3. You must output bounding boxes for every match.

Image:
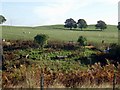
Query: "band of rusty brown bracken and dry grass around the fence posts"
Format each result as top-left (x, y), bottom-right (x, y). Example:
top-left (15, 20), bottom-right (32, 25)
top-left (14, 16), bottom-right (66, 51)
top-left (1, 64), bottom-right (120, 88)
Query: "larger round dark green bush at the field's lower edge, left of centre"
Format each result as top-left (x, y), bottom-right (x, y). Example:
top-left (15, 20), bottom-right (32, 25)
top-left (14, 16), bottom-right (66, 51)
top-left (34, 34), bottom-right (49, 48)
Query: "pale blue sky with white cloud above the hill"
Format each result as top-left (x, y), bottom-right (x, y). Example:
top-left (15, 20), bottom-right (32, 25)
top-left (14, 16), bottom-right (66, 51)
top-left (0, 0), bottom-right (119, 26)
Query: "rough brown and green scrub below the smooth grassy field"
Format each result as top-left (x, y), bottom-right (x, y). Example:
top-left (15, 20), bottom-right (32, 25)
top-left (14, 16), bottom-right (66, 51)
top-left (2, 40), bottom-right (120, 88)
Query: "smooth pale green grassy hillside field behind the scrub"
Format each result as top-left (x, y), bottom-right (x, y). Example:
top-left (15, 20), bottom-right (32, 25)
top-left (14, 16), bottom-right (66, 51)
top-left (0, 25), bottom-right (118, 43)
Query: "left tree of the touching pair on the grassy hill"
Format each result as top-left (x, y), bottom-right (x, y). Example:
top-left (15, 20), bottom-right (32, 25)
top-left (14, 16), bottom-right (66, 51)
top-left (64, 18), bottom-right (77, 30)
